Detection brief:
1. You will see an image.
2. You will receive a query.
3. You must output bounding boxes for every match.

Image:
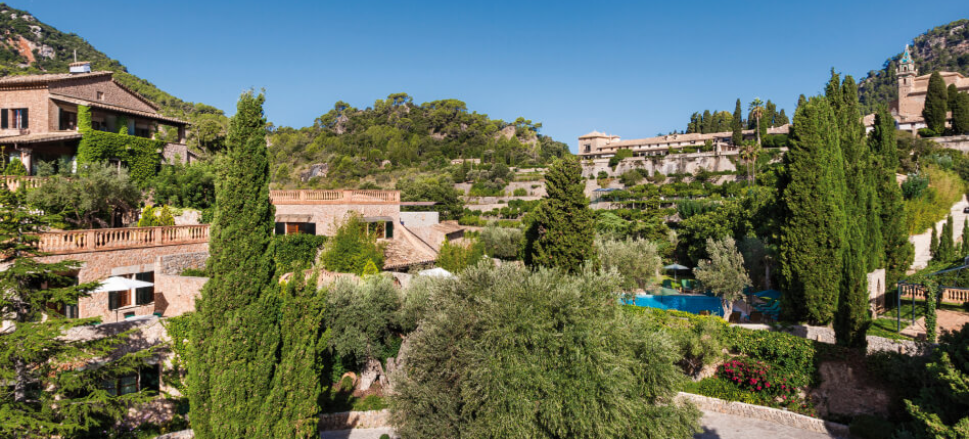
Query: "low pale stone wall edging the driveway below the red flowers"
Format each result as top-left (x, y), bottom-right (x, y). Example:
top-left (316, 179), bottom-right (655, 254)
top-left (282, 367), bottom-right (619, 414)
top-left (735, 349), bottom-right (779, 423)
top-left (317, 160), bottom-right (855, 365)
top-left (676, 392), bottom-right (850, 438)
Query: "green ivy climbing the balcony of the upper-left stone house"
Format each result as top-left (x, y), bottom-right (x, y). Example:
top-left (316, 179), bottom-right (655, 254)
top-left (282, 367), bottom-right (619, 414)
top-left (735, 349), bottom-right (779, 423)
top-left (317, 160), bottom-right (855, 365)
top-left (77, 105), bottom-right (165, 186)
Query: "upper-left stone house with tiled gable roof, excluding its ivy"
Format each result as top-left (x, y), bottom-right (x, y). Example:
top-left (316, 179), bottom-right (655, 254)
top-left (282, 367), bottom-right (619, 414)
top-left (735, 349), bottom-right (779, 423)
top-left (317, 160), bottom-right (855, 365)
top-left (0, 62), bottom-right (193, 174)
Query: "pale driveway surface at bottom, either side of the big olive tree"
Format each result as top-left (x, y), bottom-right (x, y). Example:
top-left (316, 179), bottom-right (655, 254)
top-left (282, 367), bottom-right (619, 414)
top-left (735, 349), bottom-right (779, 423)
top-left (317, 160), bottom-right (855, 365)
top-left (320, 412), bottom-right (834, 439)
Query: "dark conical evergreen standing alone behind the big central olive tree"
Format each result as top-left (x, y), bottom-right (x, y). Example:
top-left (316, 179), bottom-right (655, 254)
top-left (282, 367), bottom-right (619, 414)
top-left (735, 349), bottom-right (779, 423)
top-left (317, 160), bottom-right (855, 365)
top-left (523, 158), bottom-right (595, 273)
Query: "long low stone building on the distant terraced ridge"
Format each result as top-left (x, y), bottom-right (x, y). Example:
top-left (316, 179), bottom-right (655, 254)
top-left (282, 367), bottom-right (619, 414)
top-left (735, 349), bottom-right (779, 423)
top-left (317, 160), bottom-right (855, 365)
top-left (579, 125), bottom-right (790, 159)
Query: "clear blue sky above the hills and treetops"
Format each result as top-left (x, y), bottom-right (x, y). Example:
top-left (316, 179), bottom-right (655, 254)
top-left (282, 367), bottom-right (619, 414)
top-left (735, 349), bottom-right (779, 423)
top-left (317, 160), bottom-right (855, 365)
top-left (8, 0), bottom-right (969, 150)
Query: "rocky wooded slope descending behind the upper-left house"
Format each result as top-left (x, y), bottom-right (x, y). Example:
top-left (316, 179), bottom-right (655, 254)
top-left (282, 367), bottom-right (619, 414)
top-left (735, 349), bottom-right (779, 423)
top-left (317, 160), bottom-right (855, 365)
top-left (0, 3), bottom-right (227, 149)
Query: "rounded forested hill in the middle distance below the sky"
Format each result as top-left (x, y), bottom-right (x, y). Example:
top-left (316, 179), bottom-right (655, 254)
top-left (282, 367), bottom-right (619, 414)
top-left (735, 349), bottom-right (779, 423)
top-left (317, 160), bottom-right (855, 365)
top-left (271, 93), bottom-right (569, 187)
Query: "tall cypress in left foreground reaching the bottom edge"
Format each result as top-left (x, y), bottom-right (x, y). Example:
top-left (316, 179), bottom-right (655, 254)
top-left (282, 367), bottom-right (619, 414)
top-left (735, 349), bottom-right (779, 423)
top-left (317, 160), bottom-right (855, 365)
top-left (189, 91), bottom-right (280, 439)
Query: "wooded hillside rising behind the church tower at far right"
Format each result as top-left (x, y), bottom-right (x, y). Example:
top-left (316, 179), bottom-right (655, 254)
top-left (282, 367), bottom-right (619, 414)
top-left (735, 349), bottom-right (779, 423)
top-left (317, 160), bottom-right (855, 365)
top-left (859, 19), bottom-right (969, 114)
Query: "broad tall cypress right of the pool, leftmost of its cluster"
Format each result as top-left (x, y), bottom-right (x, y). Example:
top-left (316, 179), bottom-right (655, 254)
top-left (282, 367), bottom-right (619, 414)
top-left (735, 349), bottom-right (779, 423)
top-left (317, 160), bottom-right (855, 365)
top-left (778, 97), bottom-right (845, 324)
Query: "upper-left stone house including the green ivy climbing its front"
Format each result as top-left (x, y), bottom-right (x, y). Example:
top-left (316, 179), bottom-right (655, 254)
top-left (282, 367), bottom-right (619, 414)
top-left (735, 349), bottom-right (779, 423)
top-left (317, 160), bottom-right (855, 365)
top-left (0, 63), bottom-right (192, 183)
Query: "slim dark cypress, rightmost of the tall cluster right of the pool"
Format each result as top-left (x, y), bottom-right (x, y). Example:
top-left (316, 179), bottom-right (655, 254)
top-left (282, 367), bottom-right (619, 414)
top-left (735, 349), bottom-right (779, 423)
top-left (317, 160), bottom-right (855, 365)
top-left (868, 107), bottom-right (915, 285)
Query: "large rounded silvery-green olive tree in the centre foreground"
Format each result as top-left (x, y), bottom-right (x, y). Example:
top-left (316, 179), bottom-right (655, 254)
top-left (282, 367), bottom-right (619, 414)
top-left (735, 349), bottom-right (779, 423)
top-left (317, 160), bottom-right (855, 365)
top-left (390, 264), bottom-right (699, 439)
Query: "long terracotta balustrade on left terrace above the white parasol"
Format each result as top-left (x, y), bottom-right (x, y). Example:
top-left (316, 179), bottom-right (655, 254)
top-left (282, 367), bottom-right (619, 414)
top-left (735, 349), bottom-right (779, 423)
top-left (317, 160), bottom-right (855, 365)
top-left (37, 224), bottom-right (209, 254)
